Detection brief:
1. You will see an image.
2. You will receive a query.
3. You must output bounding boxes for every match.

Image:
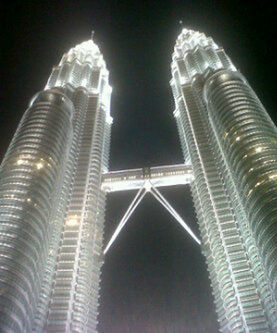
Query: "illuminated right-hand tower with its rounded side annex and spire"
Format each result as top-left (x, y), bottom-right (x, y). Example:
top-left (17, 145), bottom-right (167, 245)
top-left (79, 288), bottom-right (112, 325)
top-left (171, 29), bottom-right (277, 332)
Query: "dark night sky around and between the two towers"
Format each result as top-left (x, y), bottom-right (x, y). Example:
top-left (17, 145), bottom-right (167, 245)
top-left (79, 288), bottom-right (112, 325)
top-left (0, 0), bottom-right (276, 333)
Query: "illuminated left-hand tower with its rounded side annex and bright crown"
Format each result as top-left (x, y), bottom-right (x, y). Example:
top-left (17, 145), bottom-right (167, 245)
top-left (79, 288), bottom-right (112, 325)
top-left (0, 40), bottom-right (112, 333)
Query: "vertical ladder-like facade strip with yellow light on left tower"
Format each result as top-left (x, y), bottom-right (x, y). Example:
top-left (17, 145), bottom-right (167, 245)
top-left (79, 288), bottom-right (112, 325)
top-left (44, 97), bottom-right (97, 332)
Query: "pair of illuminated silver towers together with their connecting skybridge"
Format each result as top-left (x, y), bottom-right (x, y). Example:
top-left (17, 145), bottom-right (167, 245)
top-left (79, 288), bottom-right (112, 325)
top-left (0, 29), bottom-right (277, 333)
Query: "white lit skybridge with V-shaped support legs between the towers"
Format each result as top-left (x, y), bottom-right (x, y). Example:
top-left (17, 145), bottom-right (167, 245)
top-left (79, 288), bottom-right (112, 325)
top-left (101, 164), bottom-right (200, 254)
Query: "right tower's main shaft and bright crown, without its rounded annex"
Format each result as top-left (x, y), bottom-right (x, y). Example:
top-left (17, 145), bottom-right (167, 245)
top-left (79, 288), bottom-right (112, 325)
top-left (171, 29), bottom-right (277, 332)
